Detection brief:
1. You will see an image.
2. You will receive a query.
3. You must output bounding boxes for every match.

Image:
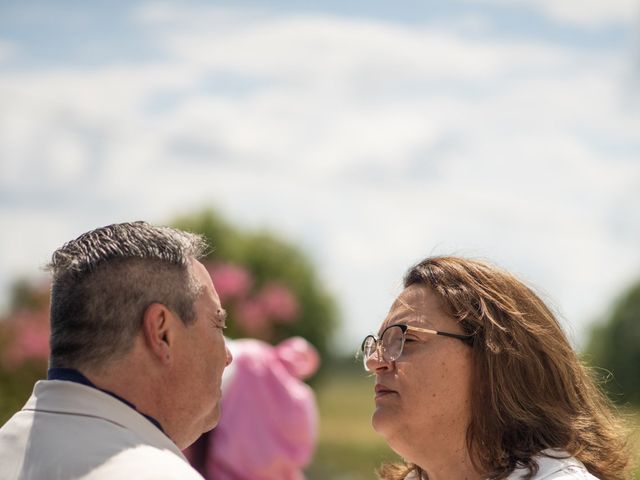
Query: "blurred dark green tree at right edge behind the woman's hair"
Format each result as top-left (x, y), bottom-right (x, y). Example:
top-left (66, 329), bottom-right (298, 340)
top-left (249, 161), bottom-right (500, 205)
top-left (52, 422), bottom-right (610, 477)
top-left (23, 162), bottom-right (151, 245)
top-left (586, 281), bottom-right (640, 406)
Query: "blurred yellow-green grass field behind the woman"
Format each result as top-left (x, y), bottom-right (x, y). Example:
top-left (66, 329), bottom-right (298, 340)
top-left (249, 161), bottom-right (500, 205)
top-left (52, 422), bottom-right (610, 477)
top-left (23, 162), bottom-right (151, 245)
top-left (306, 368), bottom-right (640, 480)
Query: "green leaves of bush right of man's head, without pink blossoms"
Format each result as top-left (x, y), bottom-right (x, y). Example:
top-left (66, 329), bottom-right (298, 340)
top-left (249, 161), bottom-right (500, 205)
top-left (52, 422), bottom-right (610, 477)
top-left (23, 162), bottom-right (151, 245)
top-left (172, 209), bottom-right (338, 364)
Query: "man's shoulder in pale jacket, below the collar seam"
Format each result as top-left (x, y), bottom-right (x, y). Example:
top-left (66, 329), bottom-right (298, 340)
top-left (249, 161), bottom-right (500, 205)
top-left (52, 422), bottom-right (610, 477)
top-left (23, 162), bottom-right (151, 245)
top-left (0, 411), bottom-right (202, 480)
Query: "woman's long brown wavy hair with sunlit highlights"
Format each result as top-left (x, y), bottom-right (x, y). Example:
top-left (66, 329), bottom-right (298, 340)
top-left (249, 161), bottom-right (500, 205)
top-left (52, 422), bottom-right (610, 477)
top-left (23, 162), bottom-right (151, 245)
top-left (378, 257), bottom-right (629, 480)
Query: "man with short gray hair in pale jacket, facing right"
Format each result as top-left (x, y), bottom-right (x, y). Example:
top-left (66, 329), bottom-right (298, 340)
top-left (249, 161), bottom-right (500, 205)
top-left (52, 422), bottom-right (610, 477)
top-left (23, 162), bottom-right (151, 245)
top-left (0, 222), bottom-right (231, 480)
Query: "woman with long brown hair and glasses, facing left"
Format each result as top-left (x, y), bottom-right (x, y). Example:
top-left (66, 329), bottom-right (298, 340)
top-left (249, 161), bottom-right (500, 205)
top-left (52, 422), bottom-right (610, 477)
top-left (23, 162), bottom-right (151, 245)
top-left (362, 257), bottom-right (630, 480)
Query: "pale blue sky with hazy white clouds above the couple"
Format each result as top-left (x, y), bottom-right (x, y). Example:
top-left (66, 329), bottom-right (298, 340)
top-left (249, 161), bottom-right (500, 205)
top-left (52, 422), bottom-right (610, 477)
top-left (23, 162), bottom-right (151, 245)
top-left (0, 0), bottom-right (640, 351)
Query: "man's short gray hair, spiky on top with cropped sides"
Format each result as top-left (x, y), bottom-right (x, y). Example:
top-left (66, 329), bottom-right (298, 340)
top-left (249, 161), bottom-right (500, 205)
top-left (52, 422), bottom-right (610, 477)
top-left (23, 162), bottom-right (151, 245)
top-left (47, 222), bottom-right (207, 369)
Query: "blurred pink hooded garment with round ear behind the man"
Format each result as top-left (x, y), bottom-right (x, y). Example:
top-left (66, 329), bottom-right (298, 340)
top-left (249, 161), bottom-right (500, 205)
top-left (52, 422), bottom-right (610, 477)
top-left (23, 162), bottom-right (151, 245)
top-left (206, 337), bottom-right (319, 480)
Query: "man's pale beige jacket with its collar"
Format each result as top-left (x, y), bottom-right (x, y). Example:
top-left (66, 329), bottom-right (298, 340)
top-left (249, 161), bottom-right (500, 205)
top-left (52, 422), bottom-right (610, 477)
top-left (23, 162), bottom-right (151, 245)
top-left (0, 380), bottom-right (202, 480)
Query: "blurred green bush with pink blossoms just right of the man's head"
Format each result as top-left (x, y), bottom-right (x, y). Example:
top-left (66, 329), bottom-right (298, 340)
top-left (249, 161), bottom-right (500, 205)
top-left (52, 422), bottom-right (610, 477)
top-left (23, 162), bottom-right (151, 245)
top-left (172, 209), bottom-right (338, 362)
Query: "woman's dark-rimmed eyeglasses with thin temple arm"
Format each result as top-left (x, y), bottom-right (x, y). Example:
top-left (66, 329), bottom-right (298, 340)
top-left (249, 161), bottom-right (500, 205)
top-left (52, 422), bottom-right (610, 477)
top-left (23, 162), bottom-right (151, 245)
top-left (361, 324), bottom-right (473, 372)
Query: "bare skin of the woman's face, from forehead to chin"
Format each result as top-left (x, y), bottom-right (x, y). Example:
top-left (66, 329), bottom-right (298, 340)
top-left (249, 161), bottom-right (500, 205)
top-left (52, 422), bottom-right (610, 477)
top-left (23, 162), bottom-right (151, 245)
top-left (367, 285), bottom-right (472, 463)
